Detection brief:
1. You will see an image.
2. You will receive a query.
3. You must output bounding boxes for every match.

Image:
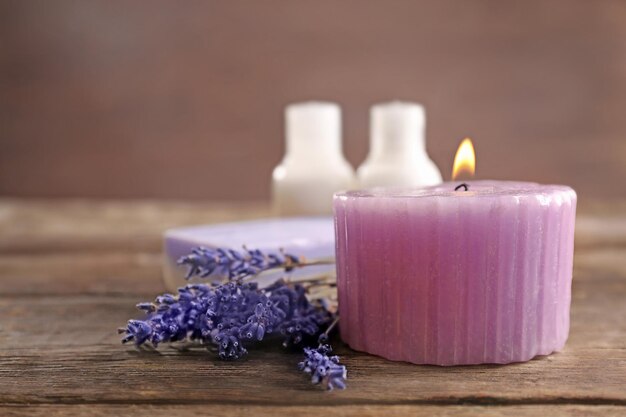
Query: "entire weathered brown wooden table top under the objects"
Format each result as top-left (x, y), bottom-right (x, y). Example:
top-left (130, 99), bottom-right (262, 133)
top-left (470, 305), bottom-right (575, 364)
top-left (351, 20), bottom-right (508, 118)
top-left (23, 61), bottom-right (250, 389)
top-left (0, 199), bottom-right (626, 416)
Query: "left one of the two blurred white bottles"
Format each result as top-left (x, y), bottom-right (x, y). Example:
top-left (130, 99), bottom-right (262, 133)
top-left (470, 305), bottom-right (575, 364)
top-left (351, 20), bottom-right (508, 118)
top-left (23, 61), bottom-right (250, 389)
top-left (272, 102), bottom-right (356, 216)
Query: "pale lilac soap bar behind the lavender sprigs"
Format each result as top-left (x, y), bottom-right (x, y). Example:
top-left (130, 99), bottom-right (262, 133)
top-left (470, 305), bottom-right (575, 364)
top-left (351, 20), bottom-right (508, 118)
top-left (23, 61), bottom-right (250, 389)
top-left (163, 217), bottom-right (335, 291)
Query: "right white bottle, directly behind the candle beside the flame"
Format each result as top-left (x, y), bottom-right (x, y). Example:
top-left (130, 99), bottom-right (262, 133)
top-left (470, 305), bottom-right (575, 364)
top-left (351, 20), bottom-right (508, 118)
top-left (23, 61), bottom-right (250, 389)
top-left (357, 101), bottom-right (441, 188)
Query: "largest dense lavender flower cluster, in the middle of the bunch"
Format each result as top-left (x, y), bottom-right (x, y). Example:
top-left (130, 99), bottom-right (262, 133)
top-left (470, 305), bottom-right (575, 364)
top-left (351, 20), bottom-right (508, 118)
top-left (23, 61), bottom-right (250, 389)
top-left (120, 280), bottom-right (331, 359)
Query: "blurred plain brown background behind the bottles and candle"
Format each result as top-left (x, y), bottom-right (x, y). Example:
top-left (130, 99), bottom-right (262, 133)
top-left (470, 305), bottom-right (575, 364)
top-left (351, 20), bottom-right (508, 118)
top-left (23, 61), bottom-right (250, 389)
top-left (0, 0), bottom-right (626, 199)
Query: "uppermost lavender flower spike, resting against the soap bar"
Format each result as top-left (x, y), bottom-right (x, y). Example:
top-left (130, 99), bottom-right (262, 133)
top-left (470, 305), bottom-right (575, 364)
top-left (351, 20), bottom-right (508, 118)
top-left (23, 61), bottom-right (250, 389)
top-left (178, 247), bottom-right (302, 280)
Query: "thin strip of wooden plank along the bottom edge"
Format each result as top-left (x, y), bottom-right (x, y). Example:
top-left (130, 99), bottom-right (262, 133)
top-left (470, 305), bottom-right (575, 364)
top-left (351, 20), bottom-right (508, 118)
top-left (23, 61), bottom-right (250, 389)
top-left (0, 404), bottom-right (626, 417)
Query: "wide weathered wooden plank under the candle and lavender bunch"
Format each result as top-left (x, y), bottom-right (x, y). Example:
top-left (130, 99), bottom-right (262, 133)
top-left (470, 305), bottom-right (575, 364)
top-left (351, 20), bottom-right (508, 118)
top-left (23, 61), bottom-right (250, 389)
top-left (0, 275), bottom-right (626, 405)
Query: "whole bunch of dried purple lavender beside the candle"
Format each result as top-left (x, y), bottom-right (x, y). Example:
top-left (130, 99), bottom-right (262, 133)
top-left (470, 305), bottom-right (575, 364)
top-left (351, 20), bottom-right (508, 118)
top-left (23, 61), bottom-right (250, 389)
top-left (119, 248), bottom-right (346, 389)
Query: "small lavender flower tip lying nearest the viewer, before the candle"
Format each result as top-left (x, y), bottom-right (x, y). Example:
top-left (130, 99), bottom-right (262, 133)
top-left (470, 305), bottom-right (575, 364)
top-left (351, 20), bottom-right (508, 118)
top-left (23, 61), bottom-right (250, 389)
top-left (298, 344), bottom-right (348, 391)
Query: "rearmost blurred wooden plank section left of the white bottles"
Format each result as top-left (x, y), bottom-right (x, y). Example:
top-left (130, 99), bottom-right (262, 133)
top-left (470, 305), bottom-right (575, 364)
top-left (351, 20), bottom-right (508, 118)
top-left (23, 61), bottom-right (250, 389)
top-left (0, 198), bottom-right (271, 254)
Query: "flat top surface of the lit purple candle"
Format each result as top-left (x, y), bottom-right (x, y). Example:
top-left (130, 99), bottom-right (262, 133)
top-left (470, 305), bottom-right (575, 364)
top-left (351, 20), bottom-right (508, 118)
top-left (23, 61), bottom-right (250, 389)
top-left (335, 180), bottom-right (576, 199)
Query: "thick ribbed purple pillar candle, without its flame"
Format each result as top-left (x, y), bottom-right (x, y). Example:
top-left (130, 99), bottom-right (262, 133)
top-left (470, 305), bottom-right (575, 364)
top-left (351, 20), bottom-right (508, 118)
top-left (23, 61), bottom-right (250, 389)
top-left (334, 181), bottom-right (576, 365)
